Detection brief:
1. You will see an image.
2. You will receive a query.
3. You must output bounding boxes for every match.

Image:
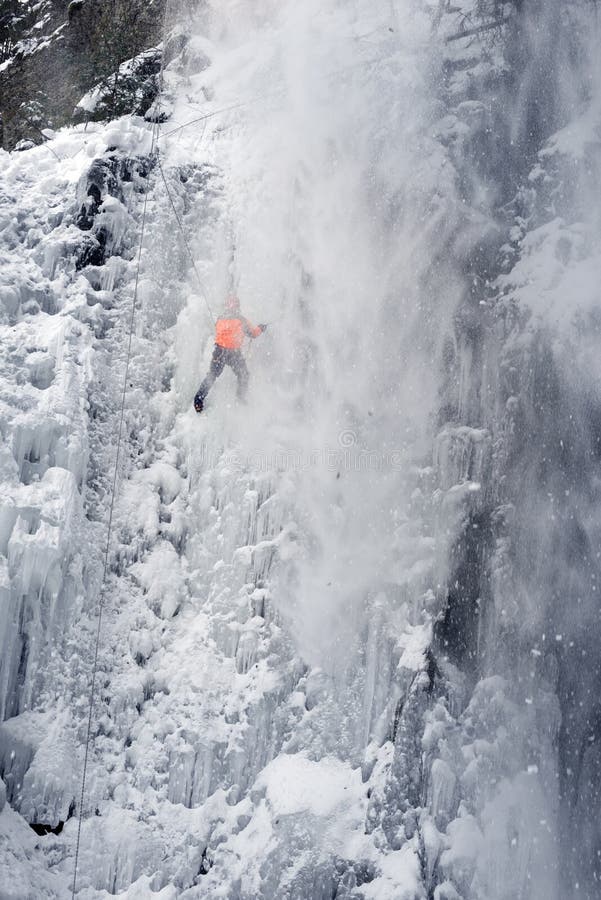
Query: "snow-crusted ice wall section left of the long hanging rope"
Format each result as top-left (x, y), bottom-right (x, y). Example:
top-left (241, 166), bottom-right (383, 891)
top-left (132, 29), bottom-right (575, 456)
top-left (0, 114), bottom-right (161, 897)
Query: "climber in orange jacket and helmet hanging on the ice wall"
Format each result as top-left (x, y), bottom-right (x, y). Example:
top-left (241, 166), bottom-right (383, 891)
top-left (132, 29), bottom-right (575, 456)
top-left (194, 294), bottom-right (267, 412)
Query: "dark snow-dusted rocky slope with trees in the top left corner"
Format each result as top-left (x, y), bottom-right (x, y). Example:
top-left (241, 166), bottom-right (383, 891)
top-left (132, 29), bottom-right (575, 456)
top-left (0, 0), bottom-right (164, 149)
